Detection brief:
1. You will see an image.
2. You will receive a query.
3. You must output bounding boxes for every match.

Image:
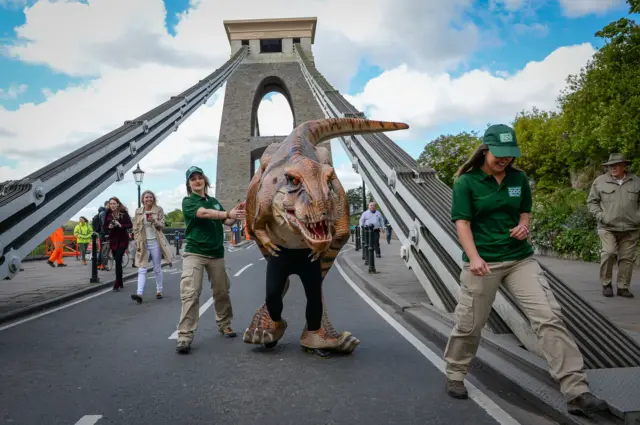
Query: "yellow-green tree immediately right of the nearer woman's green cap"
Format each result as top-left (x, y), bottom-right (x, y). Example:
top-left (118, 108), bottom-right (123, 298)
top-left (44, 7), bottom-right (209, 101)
top-left (513, 108), bottom-right (570, 189)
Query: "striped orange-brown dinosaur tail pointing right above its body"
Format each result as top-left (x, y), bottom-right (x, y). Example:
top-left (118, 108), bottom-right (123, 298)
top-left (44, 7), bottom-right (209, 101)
top-left (296, 118), bottom-right (409, 146)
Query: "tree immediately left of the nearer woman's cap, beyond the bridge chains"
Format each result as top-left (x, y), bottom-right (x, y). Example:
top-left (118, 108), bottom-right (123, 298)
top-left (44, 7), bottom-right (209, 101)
top-left (418, 132), bottom-right (482, 187)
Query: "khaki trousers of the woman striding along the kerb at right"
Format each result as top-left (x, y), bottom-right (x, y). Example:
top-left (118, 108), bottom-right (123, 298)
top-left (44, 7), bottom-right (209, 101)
top-left (444, 257), bottom-right (589, 400)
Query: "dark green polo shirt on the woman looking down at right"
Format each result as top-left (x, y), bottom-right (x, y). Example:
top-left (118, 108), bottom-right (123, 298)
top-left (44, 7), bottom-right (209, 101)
top-left (451, 169), bottom-right (533, 263)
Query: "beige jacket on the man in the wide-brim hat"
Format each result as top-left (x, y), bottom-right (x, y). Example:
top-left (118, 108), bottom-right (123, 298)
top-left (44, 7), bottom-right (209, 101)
top-left (587, 172), bottom-right (640, 232)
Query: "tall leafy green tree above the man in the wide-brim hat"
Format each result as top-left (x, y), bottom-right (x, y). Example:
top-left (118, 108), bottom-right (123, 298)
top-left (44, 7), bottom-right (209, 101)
top-left (559, 15), bottom-right (640, 169)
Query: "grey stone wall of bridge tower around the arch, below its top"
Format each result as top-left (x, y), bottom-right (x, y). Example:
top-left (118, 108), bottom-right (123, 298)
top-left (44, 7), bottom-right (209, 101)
top-left (216, 62), bottom-right (331, 209)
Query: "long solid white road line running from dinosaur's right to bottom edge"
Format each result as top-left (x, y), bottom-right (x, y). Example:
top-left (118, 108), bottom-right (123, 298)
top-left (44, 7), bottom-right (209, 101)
top-left (334, 262), bottom-right (521, 425)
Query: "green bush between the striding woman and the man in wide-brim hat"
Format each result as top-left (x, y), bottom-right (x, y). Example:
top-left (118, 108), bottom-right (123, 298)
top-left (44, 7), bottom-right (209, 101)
top-left (531, 188), bottom-right (600, 261)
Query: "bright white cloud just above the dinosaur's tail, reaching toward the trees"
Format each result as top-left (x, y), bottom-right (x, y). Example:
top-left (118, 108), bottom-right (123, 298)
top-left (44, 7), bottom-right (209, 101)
top-left (342, 43), bottom-right (595, 139)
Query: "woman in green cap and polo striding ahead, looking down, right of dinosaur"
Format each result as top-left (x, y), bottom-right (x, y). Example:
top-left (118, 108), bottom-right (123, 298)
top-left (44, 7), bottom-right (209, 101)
top-left (444, 125), bottom-right (607, 413)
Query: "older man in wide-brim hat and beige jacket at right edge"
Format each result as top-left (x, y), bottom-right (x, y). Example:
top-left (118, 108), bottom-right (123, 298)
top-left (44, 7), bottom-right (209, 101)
top-left (587, 153), bottom-right (640, 298)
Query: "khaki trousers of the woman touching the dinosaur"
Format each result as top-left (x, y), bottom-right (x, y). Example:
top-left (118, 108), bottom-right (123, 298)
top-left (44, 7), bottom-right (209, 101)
top-left (178, 253), bottom-right (233, 342)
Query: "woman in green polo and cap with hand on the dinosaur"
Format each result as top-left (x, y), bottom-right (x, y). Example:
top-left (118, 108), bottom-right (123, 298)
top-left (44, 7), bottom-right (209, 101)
top-left (176, 166), bottom-right (245, 354)
